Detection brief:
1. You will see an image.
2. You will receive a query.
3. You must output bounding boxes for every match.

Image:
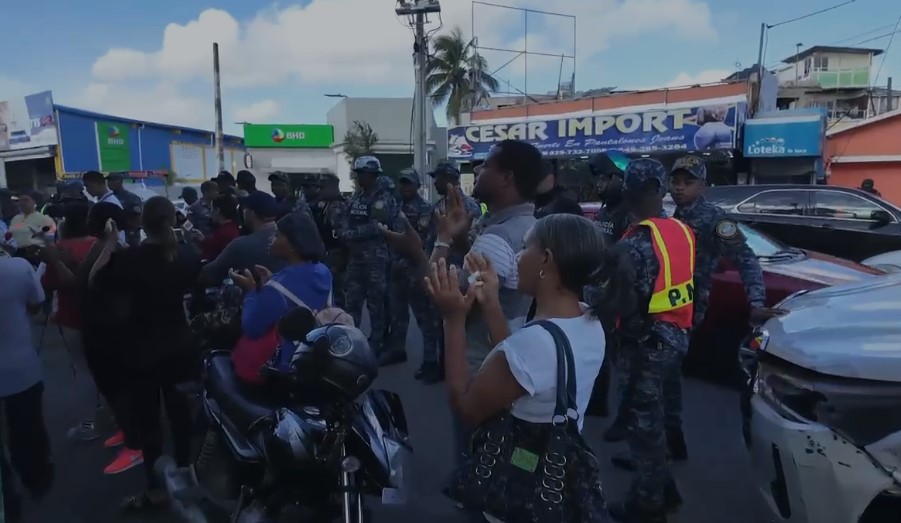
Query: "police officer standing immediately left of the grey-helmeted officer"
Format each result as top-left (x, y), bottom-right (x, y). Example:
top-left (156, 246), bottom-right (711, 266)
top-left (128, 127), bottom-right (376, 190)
top-left (311, 173), bottom-right (347, 309)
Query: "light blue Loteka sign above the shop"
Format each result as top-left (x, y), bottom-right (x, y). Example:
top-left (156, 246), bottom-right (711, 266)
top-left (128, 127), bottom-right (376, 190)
top-left (744, 114), bottom-right (826, 158)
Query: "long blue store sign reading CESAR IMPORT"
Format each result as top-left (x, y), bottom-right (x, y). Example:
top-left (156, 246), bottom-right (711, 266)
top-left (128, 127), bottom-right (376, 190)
top-left (447, 94), bottom-right (748, 191)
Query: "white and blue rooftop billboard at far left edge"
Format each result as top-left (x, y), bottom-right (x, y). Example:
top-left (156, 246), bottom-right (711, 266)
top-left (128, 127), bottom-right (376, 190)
top-left (0, 91), bottom-right (59, 151)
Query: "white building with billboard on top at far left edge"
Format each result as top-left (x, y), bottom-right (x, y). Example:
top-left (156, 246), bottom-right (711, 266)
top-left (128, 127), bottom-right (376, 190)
top-left (0, 91), bottom-right (60, 191)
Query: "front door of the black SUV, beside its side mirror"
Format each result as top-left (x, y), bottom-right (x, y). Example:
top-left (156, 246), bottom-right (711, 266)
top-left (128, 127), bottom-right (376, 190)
top-left (812, 189), bottom-right (901, 261)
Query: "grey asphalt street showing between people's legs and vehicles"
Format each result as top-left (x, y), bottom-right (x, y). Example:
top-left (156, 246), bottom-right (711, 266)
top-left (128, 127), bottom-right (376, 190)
top-left (17, 325), bottom-right (772, 523)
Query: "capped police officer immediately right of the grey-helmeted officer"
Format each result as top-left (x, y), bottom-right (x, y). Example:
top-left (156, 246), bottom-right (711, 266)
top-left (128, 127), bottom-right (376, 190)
top-left (386, 169), bottom-right (444, 378)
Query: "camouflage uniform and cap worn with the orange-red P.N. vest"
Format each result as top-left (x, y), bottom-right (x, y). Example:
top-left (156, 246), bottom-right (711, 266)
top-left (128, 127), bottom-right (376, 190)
top-left (611, 159), bottom-right (689, 513)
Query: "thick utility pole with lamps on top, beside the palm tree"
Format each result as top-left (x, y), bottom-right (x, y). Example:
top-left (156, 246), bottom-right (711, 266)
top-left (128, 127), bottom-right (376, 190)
top-left (394, 0), bottom-right (441, 199)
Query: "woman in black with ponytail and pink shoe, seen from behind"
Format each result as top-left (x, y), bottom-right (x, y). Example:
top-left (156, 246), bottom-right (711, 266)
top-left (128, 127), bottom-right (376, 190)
top-left (91, 196), bottom-right (200, 510)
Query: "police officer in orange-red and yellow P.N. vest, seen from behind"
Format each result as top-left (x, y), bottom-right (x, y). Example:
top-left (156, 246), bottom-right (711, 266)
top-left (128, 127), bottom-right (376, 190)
top-left (609, 158), bottom-right (695, 523)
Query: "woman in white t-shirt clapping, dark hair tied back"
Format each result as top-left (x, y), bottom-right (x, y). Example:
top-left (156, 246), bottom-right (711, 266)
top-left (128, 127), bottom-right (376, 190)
top-left (427, 214), bottom-right (637, 429)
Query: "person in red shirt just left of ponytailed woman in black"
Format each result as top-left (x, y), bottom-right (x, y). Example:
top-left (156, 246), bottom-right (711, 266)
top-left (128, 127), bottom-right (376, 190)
top-left (41, 201), bottom-right (99, 441)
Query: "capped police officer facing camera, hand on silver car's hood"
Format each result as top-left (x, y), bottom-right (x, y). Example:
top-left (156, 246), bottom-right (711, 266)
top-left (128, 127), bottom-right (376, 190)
top-left (666, 156), bottom-right (778, 460)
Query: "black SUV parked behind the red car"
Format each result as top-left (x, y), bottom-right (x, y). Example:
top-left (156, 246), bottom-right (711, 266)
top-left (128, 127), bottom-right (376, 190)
top-left (705, 185), bottom-right (901, 261)
